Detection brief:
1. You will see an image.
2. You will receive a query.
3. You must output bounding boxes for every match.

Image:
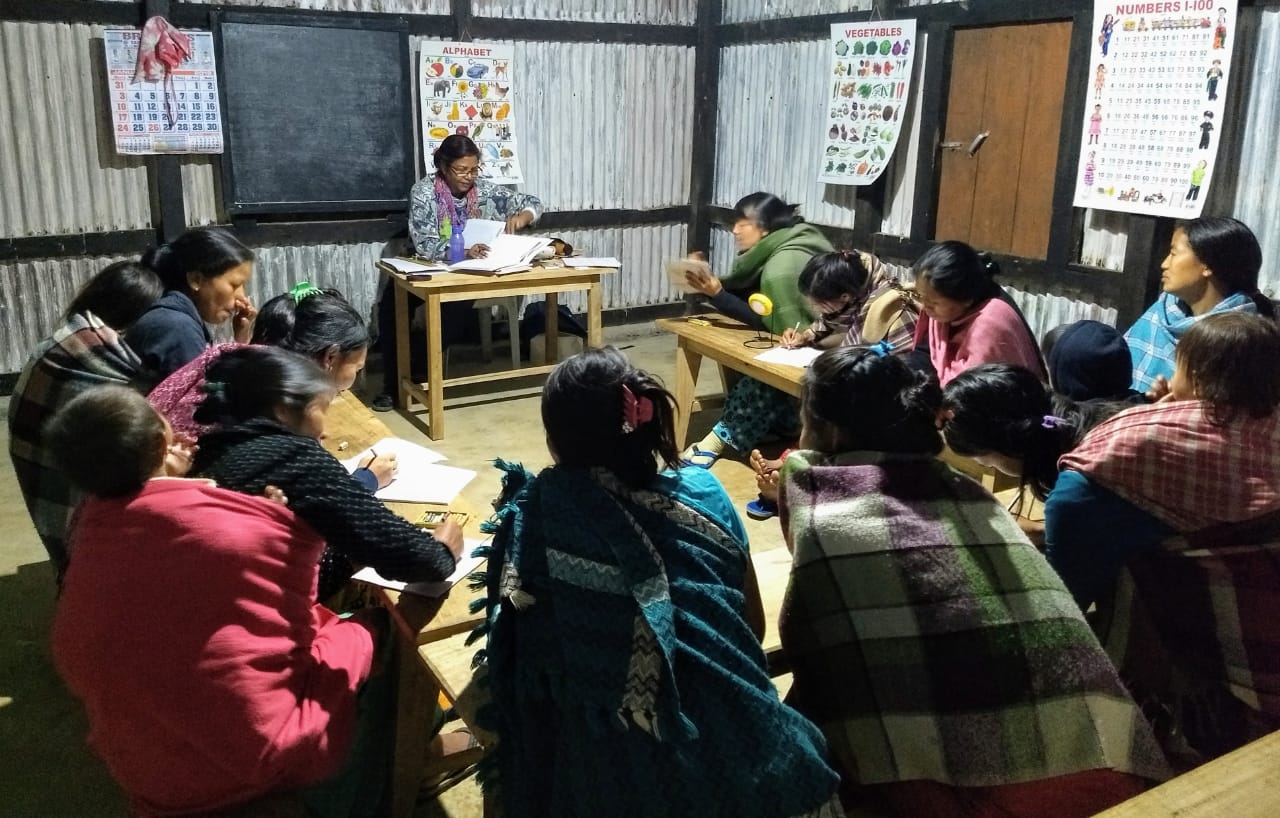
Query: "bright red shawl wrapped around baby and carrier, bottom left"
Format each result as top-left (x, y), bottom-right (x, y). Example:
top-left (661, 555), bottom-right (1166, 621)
top-left (52, 480), bottom-right (374, 814)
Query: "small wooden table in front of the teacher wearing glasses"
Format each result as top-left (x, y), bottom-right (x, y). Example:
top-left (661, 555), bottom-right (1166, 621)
top-left (379, 266), bottom-right (614, 440)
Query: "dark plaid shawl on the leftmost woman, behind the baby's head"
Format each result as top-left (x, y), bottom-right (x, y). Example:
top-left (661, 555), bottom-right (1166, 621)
top-left (9, 312), bottom-right (147, 576)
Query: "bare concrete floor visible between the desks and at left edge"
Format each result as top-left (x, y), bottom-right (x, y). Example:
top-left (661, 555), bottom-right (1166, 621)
top-left (0, 324), bottom-right (782, 818)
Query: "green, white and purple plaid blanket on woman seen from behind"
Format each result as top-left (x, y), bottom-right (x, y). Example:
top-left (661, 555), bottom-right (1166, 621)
top-left (781, 452), bottom-right (1167, 786)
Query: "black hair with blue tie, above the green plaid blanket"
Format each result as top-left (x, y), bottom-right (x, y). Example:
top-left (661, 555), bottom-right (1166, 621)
top-left (801, 347), bottom-right (942, 454)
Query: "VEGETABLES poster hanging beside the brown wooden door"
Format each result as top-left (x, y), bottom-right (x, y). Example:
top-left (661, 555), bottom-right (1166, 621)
top-left (818, 20), bottom-right (915, 184)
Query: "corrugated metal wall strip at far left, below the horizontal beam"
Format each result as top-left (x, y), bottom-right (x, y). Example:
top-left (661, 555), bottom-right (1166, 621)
top-left (0, 256), bottom-right (124, 373)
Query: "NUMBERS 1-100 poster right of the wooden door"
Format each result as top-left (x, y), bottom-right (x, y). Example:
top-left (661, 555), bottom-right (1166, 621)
top-left (1075, 0), bottom-right (1240, 219)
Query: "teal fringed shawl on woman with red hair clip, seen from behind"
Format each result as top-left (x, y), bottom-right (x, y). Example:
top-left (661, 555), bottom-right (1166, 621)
top-left (477, 461), bottom-right (837, 818)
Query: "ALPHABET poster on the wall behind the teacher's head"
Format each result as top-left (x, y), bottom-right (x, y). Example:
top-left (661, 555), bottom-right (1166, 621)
top-left (419, 42), bottom-right (525, 184)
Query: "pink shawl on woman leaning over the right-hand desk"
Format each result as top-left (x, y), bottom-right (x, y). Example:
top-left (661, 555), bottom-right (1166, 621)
top-left (915, 298), bottom-right (1046, 387)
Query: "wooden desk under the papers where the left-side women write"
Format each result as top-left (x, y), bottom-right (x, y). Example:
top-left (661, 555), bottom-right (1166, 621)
top-left (324, 392), bottom-right (484, 818)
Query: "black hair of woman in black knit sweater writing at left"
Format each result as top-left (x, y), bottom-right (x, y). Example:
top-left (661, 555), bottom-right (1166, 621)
top-left (196, 346), bottom-right (334, 426)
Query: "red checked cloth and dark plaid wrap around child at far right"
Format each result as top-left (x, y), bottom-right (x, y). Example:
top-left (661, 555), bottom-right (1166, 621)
top-left (1061, 401), bottom-right (1280, 763)
